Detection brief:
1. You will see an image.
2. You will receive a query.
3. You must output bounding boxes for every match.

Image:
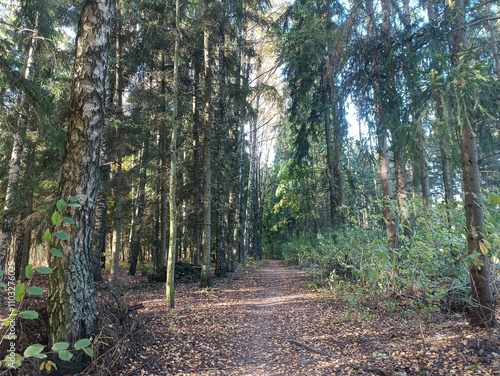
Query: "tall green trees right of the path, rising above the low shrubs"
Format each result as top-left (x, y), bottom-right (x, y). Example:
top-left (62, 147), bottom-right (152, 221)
top-left (272, 0), bottom-right (500, 324)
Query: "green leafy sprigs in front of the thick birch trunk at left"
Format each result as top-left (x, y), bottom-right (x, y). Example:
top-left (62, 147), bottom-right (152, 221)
top-left (0, 196), bottom-right (93, 372)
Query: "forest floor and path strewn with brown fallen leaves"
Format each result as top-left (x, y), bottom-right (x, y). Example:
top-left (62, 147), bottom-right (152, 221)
top-left (108, 261), bottom-right (500, 376)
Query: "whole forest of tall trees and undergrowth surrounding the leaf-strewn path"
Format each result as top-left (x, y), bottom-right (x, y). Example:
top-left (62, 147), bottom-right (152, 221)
top-left (0, 0), bottom-right (500, 375)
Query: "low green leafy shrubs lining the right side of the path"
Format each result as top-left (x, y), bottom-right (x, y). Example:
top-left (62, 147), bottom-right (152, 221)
top-left (281, 200), bottom-right (486, 312)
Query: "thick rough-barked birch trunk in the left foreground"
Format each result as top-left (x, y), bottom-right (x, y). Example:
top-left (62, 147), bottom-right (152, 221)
top-left (47, 0), bottom-right (114, 346)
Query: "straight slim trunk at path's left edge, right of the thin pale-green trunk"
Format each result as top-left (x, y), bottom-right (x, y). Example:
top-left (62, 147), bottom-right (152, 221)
top-left (200, 0), bottom-right (213, 287)
